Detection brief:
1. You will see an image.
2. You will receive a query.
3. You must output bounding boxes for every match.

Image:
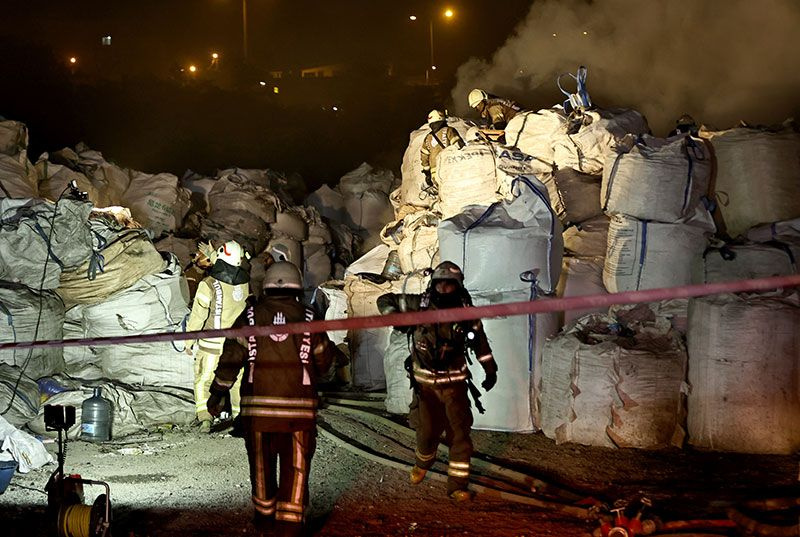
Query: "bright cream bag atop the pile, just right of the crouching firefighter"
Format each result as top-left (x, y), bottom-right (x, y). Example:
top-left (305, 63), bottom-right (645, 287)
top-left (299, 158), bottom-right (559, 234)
top-left (505, 106), bottom-right (569, 162)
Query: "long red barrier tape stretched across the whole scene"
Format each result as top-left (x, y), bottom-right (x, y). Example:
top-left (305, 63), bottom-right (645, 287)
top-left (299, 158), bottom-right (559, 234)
top-left (0, 275), bottom-right (800, 351)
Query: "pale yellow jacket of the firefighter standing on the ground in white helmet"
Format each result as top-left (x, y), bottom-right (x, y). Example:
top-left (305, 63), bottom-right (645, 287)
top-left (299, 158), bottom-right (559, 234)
top-left (186, 259), bottom-right (250, 355)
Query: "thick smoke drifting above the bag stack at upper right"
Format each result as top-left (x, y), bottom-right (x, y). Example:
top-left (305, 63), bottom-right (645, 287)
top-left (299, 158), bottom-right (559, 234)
top-left (452, 0), bottom-right (800, 135)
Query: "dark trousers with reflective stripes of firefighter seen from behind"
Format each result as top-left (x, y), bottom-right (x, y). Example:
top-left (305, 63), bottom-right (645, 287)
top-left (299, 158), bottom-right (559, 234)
top-left (245, 429), bottom-right (317, 527)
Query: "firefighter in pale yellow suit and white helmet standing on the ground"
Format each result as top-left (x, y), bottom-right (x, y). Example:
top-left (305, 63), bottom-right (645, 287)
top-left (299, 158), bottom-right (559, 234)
top-left (186, 241), bottom-right (250, 432)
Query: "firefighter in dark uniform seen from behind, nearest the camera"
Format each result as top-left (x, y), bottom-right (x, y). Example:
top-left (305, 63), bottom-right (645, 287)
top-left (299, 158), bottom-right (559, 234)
top-left (208, 261), bottom-right (336, 535)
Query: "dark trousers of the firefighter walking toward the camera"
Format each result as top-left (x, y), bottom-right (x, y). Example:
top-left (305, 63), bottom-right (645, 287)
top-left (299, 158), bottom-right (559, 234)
top-left (415, 382), bottom-right (472, 494)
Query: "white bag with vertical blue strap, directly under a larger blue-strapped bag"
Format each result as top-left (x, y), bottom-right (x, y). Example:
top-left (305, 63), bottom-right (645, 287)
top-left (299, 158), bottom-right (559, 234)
top-left (603, 214), bottom-right (709, 293)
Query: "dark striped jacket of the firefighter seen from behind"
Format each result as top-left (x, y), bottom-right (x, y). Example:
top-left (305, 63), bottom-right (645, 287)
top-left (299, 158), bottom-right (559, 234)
top-left (211, 296), bottom-right (335, 432)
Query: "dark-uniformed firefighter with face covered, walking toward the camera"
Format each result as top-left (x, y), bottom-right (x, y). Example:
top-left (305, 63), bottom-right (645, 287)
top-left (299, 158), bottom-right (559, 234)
top-left (378, 261), bottom-right (497, 501)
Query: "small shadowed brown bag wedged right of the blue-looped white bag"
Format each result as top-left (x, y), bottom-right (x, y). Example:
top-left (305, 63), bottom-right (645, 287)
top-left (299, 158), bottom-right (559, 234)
top-left (539, 168), bottom-right (603, 226)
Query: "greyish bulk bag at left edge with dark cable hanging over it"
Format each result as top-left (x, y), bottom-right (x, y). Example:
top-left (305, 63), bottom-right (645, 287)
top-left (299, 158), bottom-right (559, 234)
top-left (0, 198), bottom-right (92, 289)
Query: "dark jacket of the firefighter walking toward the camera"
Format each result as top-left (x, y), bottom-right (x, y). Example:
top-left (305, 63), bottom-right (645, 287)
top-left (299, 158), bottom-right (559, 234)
top-left (378, 290), bottom-right (497, 388)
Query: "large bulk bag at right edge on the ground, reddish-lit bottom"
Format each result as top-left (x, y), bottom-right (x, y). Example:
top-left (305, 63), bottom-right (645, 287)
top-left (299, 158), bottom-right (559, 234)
top-left (687, 292), bottom-right (800, 455)
